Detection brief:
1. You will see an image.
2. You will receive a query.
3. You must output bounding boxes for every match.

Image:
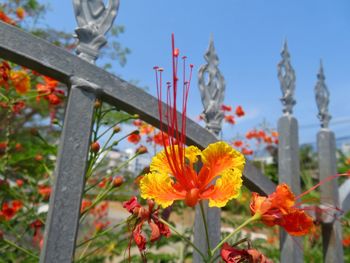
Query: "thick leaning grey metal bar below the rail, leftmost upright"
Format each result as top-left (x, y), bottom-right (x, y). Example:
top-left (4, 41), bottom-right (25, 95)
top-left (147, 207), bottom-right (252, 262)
top-left (40, 83), bottom-right (95, 263)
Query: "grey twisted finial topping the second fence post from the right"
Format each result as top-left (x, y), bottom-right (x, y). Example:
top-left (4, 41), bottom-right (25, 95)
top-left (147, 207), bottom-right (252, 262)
top-left (277, 40), bottom-right (296, 114)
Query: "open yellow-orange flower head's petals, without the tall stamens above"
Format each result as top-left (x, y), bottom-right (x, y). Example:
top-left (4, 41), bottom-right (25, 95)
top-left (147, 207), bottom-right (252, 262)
top-left (140, 142), bottom-right (245, 208)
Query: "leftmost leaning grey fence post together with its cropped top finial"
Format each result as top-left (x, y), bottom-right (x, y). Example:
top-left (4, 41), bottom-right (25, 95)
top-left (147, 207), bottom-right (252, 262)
top-left (40, 0), bottom-right (119, 263)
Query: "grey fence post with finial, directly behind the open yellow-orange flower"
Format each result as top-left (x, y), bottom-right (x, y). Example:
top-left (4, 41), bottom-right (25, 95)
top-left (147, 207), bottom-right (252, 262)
top-left (193, 36), bottom-right (225, 263)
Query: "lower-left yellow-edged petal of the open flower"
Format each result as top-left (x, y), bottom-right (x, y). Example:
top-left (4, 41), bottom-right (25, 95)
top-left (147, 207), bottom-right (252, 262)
top-left (140, 173), bottom-right (186, 208)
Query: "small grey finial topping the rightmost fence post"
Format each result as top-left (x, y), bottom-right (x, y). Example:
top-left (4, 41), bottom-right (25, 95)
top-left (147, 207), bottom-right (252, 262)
top-left (315, 60), bottom-right (332, 128)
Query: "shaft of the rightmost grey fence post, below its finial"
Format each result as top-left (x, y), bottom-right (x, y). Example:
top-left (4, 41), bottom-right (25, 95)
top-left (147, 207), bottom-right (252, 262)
top-left (317, 129), bottom-right (344, 263)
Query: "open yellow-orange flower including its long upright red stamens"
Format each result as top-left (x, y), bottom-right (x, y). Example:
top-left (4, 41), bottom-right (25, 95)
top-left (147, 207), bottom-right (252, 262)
top-left (140, 36), bottom-right (245, 208)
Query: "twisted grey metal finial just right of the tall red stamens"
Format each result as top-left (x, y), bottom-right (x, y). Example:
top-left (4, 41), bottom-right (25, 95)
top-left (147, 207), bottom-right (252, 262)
top-left (198, 35), bottom-right (225, 135)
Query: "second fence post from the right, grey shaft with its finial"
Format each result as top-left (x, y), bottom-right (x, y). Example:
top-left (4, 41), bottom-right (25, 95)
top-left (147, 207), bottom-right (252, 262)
top-left (277, 41), bottom-right (303, 263)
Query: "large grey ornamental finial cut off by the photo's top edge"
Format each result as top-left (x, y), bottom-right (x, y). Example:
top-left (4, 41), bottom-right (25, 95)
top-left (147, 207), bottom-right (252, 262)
top-left (73, 0), bottom-right (119, 63)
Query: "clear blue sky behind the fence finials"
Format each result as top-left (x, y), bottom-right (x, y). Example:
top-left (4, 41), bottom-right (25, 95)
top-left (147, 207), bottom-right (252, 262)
top-left (42, 0), bottom-right (350, 143)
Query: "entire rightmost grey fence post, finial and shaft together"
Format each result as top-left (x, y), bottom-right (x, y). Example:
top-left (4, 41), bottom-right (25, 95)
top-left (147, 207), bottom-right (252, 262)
top-left (315, 61), bottom-right (344, 263)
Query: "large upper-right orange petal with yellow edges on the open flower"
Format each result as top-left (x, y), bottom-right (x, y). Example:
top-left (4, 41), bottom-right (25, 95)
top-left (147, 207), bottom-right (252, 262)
top-left (199, 142), bottom-right (245, 188)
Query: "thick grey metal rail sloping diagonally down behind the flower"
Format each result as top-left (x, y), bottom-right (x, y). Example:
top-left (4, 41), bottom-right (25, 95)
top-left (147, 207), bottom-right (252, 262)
top-left (0, 21), bottom-right (275, 194)
